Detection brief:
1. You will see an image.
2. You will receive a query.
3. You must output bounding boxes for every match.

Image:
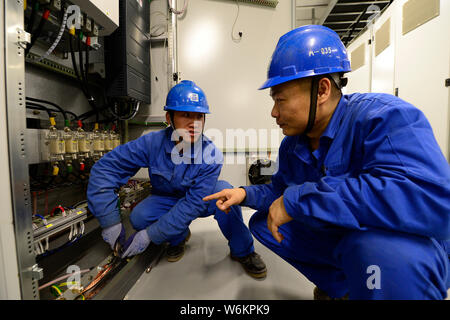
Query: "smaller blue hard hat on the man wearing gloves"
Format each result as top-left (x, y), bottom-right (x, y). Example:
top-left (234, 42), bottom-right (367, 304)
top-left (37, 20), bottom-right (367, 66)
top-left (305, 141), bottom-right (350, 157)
top-left (164, 80), bottom-right (210, 113)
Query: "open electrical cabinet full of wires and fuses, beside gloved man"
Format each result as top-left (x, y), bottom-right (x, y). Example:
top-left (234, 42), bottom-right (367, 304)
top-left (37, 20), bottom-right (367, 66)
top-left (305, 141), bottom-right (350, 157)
top-left (0, 0), bottom-right (175, 299)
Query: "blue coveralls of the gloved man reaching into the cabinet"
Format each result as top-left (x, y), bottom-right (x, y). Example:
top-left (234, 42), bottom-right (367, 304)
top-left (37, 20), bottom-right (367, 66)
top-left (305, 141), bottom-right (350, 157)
top-left (87, 127), bottom-right (254, 257)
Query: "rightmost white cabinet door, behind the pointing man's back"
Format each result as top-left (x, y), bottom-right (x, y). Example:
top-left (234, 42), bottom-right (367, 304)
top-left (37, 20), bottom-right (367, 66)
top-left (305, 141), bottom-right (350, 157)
top-left (394, 0), bottom-right (450, 160)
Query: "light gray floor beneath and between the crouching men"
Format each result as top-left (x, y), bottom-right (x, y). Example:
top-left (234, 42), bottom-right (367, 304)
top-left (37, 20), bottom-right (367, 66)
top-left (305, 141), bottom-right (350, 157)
top-left (125, 209), bottom-right (314, 300)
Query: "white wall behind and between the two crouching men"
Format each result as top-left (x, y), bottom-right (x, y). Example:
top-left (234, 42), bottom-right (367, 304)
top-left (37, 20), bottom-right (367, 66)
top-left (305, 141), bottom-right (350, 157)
top-left (150, 0), bottom-right (292, 186)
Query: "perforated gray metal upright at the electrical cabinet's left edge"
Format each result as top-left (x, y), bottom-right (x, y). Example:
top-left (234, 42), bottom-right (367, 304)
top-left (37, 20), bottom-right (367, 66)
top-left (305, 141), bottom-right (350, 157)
top-left (5, 0), bottom-right (39, 299)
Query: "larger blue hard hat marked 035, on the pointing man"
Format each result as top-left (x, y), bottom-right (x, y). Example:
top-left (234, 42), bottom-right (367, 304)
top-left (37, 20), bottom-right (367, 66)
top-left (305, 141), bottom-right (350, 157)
top-left (259, 25), bottom-right (351, 90)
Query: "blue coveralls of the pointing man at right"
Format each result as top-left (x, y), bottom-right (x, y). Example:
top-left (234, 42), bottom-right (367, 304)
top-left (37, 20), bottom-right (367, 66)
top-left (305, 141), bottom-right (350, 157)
top-left (242, 94), bottom-right (450, 299)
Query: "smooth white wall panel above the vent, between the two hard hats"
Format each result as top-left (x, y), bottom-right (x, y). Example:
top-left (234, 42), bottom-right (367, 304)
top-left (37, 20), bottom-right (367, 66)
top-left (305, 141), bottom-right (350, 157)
top-left (174, 0), bottom-right (292, 147)
